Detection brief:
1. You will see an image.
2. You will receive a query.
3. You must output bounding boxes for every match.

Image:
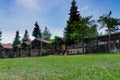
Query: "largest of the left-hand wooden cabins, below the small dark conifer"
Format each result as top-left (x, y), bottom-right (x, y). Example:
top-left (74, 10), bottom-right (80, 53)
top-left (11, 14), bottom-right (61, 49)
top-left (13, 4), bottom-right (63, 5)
top-left (31, 38), bottom-right (50, 56)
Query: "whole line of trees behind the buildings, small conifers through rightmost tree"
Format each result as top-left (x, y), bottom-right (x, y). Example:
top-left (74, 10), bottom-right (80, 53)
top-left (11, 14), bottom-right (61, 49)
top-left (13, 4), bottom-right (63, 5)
top-left (0, 0), bottom-right (120, 52)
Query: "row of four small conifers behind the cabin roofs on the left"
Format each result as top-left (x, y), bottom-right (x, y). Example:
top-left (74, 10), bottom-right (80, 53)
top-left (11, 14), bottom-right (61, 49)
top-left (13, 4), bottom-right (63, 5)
top-left (13, 22), bottom-right (52, 46)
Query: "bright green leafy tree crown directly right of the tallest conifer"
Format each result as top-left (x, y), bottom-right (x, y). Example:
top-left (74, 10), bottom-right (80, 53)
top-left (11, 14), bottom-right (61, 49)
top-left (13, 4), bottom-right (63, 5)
top-left (71, 16), bottom-right (98, 43)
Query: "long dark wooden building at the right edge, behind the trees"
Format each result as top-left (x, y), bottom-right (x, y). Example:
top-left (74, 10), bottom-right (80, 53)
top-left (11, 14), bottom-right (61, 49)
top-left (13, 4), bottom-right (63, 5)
top-left (85, 32), bottom-right (120, 53)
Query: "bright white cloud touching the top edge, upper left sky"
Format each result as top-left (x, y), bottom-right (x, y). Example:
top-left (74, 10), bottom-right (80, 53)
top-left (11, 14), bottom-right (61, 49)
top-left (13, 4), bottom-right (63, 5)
top-left (16, 0), bottom-right (39, 10)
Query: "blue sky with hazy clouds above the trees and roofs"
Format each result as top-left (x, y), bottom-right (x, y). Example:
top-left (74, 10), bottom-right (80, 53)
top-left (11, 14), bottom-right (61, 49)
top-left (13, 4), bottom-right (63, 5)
top-left (0, 0), bottom-right (120, 43)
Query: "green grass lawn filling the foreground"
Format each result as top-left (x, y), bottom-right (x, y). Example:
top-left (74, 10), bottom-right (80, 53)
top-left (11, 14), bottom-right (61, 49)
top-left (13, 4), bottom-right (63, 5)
top-left (0, 53), bottom-right (120, 80)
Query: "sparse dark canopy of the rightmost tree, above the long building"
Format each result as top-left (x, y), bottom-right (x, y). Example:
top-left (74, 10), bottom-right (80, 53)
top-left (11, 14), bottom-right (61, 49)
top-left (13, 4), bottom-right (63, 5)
top-left (98, 11), bottom-right (120, 33)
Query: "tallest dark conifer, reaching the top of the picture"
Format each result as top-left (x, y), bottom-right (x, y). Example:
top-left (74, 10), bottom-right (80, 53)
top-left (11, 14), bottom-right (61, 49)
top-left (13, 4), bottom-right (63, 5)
top-left (64, 0), bottom-right (81, 45)
